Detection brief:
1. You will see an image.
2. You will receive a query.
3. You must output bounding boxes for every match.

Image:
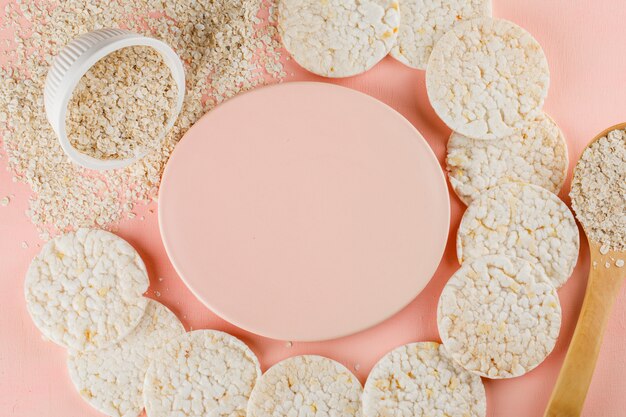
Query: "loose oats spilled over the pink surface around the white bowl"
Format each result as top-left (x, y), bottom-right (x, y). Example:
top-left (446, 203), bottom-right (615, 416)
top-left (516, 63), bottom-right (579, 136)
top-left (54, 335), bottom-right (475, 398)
top-left (0, 0), bottom-right (285, 239)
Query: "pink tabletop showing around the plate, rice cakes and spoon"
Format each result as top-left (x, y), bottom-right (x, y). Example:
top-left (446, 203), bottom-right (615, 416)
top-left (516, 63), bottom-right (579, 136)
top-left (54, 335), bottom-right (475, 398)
top-left (0, 0), bottom-right (626, 417)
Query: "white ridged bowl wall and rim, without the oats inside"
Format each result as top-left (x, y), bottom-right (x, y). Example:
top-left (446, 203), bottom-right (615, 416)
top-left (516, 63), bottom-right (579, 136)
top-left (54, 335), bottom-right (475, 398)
top-left (44, 29), bottom-right (185, 170)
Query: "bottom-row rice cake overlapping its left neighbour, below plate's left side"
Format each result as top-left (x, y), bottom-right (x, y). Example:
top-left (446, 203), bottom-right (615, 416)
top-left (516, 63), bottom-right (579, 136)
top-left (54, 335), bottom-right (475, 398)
top-left (143, 330), bottom-right (261, 417)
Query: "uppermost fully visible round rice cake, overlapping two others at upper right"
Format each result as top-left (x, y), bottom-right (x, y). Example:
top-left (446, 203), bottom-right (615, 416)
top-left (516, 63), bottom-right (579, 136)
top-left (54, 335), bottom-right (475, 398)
top-left (426, 18), bottom-right (550, 139)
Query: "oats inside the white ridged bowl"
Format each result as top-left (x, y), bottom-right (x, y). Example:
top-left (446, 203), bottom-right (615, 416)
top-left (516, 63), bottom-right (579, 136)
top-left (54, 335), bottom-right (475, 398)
top-left (66, 46), bottom-right (178, 159)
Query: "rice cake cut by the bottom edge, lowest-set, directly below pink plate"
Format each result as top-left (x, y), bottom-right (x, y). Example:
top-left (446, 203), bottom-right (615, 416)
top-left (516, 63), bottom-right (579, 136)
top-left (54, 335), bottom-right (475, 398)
top-left (248, 355), bottom-right (363, 417)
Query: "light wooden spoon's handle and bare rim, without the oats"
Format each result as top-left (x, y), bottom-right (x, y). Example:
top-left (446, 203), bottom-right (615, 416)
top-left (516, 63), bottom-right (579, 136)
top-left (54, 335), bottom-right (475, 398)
top-left (544, 123), bottom-right (626, 417)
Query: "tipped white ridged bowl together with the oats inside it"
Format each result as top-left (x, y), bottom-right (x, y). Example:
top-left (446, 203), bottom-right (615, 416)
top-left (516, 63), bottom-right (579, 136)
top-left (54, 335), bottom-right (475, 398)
top-left (44, 29), bottom-right (185, 170)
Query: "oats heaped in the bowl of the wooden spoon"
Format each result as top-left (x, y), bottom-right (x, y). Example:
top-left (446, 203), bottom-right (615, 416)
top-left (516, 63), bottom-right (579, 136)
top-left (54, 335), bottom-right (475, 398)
top-left (570, 130), bottom-right (626, 252)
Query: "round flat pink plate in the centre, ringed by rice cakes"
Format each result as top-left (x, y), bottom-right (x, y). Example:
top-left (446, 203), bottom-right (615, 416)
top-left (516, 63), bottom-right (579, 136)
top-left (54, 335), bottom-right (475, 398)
top-left (159, 83), bottom-right (450, 341)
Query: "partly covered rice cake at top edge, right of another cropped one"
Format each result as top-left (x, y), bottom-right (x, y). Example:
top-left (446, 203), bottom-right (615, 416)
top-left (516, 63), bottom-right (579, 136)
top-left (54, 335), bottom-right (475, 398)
top-left (390, 0), bottom-right (491, 70)
